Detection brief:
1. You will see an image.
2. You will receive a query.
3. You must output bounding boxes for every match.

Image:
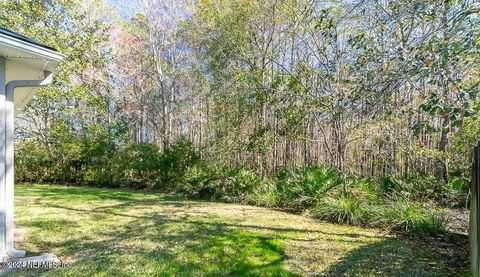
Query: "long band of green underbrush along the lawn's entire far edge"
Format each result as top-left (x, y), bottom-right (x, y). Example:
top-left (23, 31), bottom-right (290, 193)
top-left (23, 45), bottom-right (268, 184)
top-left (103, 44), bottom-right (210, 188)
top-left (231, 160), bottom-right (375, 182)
top-left (16, 139), bottom-right (468, 235)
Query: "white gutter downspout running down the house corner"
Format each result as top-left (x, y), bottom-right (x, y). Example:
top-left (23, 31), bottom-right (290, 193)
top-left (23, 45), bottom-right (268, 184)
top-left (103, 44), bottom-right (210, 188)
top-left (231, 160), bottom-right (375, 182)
top-left (5, 71), bottom-right (53, 258)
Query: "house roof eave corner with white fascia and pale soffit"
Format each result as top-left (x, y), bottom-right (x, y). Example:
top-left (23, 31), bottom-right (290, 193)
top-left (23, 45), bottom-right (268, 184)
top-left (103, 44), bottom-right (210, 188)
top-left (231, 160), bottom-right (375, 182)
top-left (0, 29), bottom-right (64, 115)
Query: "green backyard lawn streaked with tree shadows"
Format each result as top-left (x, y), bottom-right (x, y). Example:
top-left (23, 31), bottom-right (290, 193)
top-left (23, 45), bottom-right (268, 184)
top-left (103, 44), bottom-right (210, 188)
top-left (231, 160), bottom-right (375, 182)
top-left (6, 185), bottom-right (468, 276)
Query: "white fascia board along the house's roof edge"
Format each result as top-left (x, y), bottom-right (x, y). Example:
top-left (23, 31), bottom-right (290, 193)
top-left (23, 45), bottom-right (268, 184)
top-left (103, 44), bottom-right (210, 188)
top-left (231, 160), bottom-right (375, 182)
top-left (0, 34), bottom-right (65, 62)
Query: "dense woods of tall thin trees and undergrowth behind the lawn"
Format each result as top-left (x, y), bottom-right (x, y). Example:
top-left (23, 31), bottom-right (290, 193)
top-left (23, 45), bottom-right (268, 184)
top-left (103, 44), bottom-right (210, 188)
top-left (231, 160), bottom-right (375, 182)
top-left (0, 0), bottom-right (480, 233)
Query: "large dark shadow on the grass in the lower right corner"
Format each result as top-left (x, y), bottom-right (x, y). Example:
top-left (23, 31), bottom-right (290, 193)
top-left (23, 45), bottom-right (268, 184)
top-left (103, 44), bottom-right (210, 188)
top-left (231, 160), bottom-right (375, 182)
top-left (322, 235), bottom-right (469, 277)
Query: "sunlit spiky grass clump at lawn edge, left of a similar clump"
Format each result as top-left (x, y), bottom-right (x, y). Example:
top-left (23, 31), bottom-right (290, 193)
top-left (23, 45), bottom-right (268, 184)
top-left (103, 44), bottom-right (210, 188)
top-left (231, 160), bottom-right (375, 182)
top-left (310, 195), bottom-right (368, 225)
